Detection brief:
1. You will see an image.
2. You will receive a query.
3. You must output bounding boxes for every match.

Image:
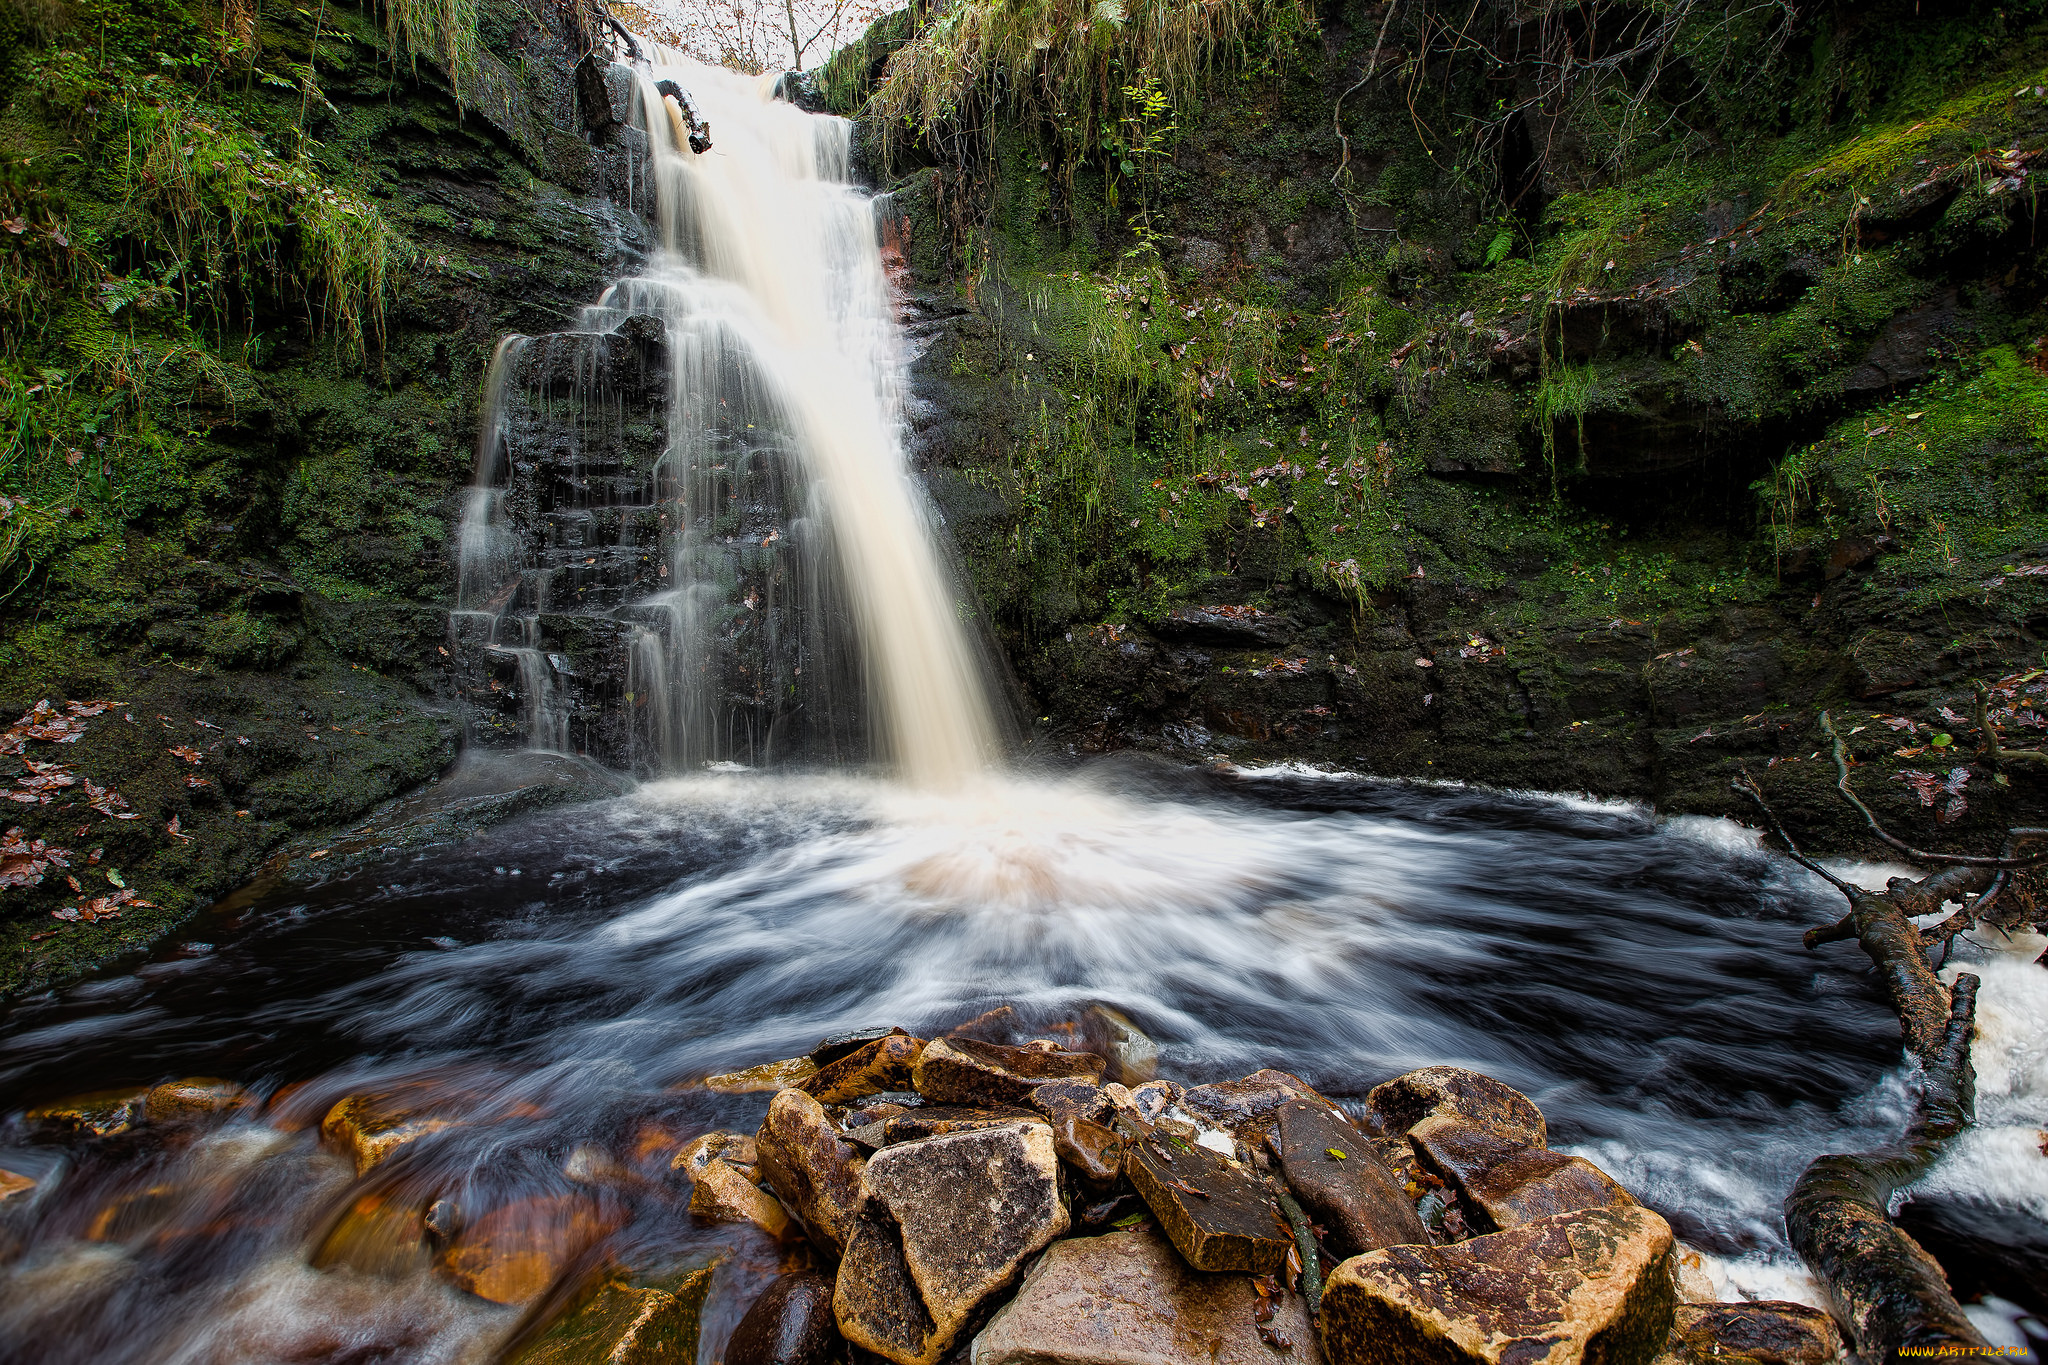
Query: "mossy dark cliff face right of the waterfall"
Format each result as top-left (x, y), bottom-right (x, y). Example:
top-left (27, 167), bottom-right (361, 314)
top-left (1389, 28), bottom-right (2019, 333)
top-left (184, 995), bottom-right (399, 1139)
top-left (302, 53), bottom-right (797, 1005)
top-left (827, 4), bottom-right (2048, 847)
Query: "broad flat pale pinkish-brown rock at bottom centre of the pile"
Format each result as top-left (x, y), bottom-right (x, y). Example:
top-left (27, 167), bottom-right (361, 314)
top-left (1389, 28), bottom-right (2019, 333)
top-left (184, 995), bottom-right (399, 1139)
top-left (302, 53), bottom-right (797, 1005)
top-left (974, 1228), bottom-right (1321, 1365)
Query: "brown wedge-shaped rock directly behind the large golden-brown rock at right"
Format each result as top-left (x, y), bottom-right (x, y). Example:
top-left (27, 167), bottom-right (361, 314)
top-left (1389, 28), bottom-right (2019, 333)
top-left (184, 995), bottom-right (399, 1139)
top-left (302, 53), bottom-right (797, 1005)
top-left (1409, 1113), bottom-right (1634, 1232)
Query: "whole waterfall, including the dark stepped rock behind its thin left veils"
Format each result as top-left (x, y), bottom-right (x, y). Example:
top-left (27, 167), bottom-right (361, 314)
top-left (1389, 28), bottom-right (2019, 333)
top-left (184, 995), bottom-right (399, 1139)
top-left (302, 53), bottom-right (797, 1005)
top-left (457, 53), bottom-right (997, 786)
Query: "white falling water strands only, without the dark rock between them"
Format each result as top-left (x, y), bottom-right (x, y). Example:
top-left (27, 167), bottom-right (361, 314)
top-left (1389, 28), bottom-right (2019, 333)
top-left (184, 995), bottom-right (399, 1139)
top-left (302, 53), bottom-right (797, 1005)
top-left (459, 53), bottom-right (997, 786)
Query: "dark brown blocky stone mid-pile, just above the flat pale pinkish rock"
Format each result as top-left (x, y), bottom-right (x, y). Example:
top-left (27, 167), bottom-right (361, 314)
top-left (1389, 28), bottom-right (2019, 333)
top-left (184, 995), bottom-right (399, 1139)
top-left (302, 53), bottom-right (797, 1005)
top-left (1124, 1138), bottom-right (1294, 1275)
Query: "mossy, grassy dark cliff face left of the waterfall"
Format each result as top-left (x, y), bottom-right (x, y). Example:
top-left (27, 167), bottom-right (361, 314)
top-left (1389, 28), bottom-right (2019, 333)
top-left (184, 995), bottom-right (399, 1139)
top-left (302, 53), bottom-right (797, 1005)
top-left (0, 0), bottom-right (637, 988)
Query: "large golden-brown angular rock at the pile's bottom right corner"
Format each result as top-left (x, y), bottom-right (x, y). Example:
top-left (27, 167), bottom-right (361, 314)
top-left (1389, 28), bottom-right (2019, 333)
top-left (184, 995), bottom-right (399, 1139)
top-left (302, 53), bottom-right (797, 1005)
top-left (1321, 1207), bottom-right (1673, 1365)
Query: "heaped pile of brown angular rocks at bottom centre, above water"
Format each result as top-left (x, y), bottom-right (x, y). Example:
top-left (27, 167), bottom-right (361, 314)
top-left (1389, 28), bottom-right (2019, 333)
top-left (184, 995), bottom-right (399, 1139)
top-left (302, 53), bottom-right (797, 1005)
top-left (692, 1025), bottom-right (1841, 1365)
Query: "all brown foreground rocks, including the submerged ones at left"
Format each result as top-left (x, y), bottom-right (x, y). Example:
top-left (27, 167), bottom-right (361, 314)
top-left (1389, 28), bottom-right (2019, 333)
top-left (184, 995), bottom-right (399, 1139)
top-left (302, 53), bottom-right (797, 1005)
top-left (0, 1009), bottom-right (1843, 1365)
